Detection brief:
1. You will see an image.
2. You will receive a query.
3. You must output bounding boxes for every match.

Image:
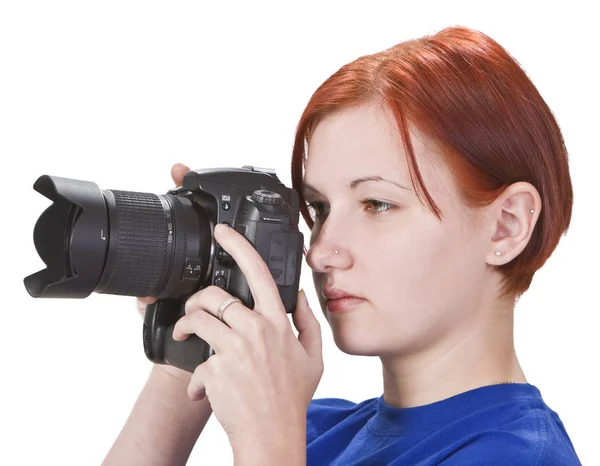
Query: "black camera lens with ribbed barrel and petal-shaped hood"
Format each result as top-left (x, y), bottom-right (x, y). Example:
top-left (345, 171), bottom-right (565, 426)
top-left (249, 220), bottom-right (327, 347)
top-left (24, 175), bottom-right (212, 299)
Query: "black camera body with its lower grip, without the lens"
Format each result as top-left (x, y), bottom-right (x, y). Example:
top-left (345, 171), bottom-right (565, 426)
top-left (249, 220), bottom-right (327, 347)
top-left (143, 165), bottom-right (304, 372)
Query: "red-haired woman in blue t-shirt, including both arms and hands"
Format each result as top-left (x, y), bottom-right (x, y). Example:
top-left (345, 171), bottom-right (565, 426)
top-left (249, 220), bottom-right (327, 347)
top-left (107, 27), bottom-right (580, 465)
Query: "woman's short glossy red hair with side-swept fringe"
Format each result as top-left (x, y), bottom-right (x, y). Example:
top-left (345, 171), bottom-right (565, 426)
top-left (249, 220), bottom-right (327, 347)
top-left (291, 27), bottom-right (573, 299)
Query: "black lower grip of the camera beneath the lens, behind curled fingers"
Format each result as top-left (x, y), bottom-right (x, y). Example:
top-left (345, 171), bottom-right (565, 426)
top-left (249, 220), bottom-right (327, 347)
top-left (143, 299), bottom-right (214, 373)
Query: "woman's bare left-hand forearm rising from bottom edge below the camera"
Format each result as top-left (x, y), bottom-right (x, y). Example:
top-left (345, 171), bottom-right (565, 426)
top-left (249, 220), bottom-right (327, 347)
top-left (102, 367), bottom-right (212, 466)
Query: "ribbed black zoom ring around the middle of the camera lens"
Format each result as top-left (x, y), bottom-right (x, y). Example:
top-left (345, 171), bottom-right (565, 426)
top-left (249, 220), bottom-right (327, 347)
top-left (103, 190), bottom-right (168, 296)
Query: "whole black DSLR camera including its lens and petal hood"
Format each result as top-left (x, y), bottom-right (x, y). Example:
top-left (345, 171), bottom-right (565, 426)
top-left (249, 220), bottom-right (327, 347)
top-left (24, 165), bottom-right (304, 372)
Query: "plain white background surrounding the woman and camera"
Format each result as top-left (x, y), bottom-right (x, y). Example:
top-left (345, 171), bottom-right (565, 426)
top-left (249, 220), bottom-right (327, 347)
top-left (0, 0), bottom-right (600, 465)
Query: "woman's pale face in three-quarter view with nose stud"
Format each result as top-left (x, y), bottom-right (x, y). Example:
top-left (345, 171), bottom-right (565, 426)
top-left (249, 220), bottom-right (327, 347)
top-left (304, 106), bottom-right (492, 355)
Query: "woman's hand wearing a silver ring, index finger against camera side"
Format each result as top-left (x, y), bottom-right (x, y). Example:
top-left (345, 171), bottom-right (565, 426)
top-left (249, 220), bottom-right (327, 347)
top-left (173, 225), bottom-right (323, 452)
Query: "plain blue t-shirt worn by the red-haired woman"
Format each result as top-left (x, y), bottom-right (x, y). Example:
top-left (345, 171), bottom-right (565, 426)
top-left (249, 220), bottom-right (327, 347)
top-left (306, 383), bottom-right (581, 466)
